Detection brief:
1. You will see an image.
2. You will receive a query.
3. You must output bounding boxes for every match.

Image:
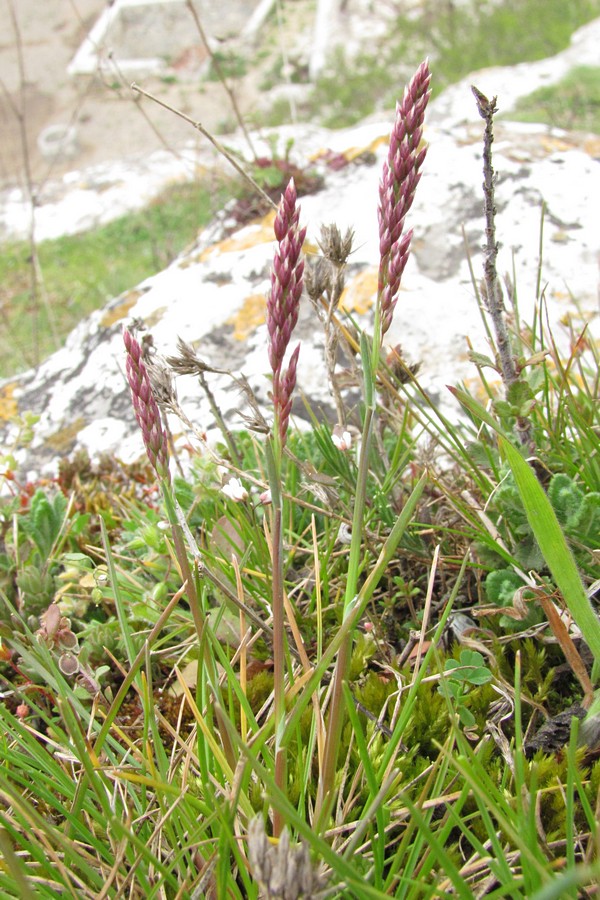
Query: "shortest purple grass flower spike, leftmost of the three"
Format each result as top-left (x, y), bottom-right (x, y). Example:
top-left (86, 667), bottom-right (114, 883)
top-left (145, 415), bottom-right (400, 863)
top-left (123, 328), bottom-right (170, 479)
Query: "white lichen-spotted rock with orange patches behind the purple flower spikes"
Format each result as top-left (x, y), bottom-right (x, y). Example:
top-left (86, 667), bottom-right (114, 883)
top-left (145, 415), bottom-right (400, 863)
top-left (0, 44), bottom-right (600, 475)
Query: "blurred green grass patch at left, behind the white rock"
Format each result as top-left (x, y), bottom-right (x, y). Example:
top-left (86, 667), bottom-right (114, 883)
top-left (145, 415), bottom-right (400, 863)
top-left (0, 182), bottom-right (231, 377)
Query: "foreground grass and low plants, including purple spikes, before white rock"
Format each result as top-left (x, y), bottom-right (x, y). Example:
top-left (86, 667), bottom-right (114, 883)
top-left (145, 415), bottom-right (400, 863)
top-left (0, 64), bottom-right (600, 900)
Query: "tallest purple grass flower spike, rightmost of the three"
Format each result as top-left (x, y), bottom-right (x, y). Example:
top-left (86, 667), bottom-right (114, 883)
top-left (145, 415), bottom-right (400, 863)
top-left (377, 60), bottom-right (431, 338)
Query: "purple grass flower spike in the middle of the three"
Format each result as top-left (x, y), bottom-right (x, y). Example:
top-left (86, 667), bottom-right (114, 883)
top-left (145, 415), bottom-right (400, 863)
top-left (267, 178), bottom-right (306, 447)
